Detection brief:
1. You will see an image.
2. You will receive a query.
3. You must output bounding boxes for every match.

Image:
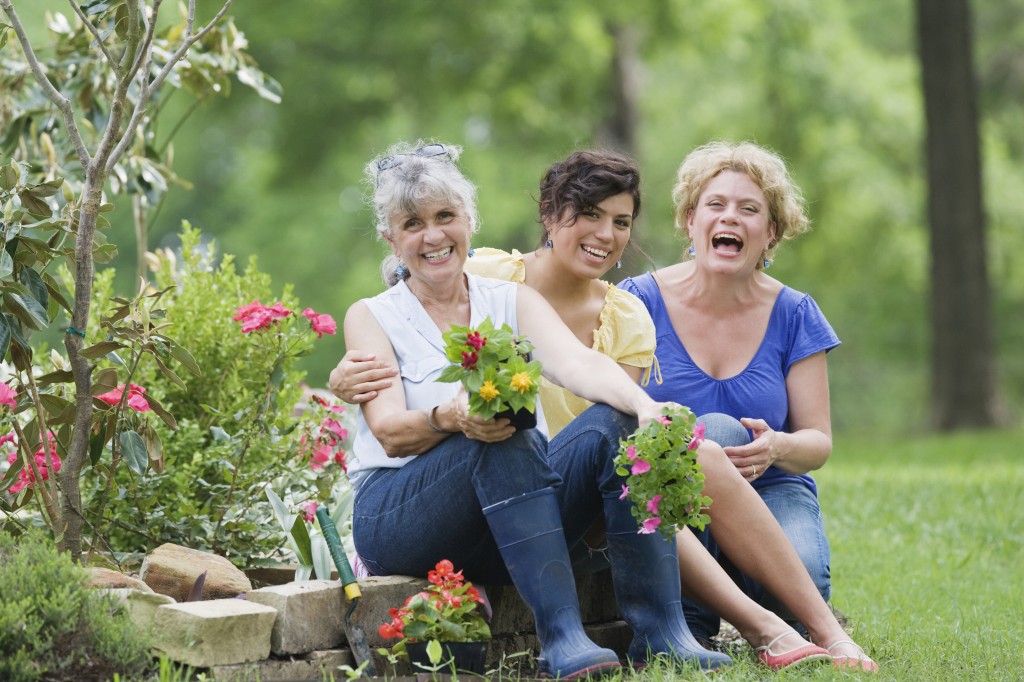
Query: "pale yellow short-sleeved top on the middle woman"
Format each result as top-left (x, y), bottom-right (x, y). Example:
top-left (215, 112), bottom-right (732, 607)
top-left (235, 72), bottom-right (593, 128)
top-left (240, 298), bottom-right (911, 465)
top-left (465, 248), bottom-right (657, 438)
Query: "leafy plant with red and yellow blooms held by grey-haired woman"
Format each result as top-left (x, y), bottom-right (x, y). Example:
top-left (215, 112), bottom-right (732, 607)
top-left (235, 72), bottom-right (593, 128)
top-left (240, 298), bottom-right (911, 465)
top-left (437, 317), bottom-right (541, 419)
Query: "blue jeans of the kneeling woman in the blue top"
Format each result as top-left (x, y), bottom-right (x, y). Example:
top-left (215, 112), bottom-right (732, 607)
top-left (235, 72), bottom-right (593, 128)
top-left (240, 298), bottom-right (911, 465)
top-left (683, 414), bottom-right (831, 639)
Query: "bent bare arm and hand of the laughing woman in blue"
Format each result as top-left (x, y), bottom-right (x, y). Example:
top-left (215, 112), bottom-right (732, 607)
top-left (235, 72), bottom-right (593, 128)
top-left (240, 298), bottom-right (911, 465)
top-left (725, 350), bottom-right (831, 479)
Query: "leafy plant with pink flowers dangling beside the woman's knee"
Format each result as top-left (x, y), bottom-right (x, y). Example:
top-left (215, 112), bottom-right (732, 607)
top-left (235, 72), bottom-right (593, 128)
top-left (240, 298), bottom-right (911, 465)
top-left (615, 406), bottom-right (712, 538)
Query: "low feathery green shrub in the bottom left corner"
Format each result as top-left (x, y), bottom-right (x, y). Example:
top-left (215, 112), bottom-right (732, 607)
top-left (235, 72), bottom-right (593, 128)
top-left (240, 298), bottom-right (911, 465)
top-left (0, 531), bottom-right (150, 682)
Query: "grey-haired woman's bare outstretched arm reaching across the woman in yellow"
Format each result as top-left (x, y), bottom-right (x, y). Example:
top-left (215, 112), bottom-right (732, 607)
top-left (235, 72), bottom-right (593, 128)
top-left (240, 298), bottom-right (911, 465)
top-left (516, 285), bottom-right (664, 424)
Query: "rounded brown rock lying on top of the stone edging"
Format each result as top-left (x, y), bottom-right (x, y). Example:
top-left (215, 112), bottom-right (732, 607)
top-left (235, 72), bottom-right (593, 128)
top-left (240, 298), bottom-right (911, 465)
top-left (139, 543), bottom-right (252, 601)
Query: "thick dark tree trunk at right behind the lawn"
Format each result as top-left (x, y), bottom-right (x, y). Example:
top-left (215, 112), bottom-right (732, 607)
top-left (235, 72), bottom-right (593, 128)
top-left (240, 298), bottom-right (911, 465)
top-left (916, 0), bottom-right (997, 430)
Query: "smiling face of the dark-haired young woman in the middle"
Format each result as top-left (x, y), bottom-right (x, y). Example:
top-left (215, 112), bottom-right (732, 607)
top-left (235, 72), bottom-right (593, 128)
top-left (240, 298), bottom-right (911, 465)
top-left (546, 193), bottom-right (634, 280)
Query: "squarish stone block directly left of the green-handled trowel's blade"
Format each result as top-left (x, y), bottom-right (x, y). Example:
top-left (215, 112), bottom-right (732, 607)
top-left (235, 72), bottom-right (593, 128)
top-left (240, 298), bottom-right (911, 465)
top-left (247, 581), bottom-right (348, 655)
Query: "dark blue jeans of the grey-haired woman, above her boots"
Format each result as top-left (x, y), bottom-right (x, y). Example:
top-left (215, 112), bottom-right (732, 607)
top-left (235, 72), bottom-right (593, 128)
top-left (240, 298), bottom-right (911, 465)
top-left (352, 404), bottom-right (637, 585)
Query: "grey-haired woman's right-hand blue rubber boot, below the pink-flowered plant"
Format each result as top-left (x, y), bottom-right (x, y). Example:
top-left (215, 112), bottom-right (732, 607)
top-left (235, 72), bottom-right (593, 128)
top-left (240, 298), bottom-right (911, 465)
top-left (604, 499), bottom-right (732, 670)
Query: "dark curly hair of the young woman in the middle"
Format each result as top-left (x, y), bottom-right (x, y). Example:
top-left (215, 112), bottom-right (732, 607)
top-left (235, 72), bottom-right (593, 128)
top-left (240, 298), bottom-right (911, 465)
top-left (538, 150), bottom-right (640, 245)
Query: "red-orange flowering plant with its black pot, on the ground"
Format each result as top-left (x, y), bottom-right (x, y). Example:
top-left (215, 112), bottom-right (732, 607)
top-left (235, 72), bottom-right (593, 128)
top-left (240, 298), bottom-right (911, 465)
top-left (378, 559), bottom-right (490, 675)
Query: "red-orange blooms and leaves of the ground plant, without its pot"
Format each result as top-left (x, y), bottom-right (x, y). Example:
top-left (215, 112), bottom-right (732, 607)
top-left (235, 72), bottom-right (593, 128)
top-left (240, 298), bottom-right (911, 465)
top-left (378, 559), bottom-right (490, 656)
